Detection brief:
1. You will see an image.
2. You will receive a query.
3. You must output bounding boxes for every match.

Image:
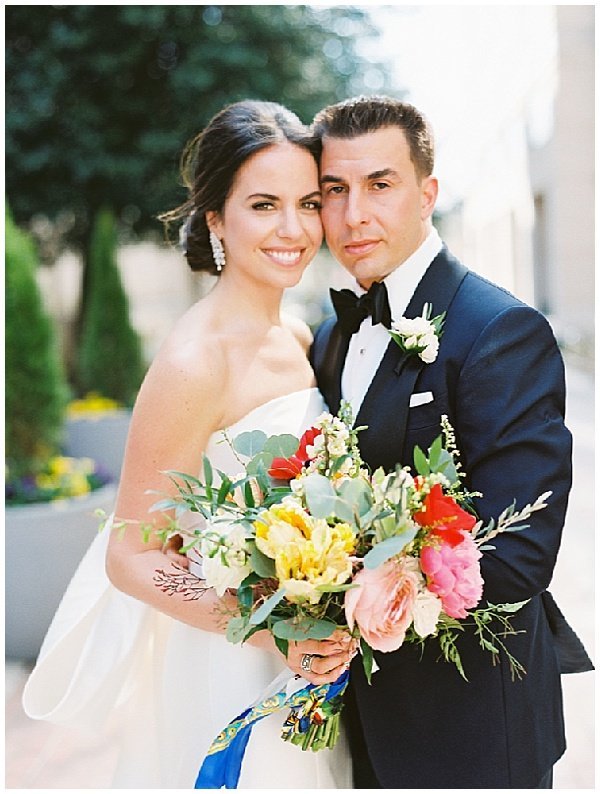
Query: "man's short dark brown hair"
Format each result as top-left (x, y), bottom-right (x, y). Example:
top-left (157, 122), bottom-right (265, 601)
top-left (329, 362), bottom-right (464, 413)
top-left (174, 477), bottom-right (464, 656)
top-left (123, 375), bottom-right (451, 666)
top-left (313, 95), bottom-right (434, 177)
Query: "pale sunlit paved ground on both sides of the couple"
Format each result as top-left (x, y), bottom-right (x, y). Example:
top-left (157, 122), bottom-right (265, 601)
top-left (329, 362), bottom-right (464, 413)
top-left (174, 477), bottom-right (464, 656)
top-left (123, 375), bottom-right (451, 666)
top-left (5, 370), bottom-right (595, 789)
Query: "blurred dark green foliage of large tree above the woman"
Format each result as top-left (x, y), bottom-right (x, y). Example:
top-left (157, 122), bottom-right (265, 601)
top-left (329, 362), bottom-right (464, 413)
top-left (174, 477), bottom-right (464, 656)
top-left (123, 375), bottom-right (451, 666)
top-left (5, 5), bottom-right (387, 262)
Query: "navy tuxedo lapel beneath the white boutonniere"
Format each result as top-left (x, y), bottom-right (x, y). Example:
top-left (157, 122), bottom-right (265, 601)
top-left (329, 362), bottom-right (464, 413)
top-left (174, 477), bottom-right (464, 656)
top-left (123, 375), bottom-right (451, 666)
top-left (356, 246), bottom-right (468, 470)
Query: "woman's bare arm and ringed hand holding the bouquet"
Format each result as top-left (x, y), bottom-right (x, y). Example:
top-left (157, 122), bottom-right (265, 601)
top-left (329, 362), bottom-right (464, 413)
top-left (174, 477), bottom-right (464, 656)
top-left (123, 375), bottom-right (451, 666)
top-left (106, 340), bottom-right (351, 684)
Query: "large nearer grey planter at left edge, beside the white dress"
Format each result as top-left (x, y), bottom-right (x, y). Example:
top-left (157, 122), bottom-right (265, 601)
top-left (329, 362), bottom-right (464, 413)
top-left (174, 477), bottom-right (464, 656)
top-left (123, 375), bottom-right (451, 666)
top-left (5, 484), bottom-right (116, 660)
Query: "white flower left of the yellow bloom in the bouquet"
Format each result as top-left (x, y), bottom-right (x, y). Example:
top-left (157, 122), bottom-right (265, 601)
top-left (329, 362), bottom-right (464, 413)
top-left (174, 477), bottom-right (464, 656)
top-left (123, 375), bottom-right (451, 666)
top-left (200, 524), bottom-right (252, 597)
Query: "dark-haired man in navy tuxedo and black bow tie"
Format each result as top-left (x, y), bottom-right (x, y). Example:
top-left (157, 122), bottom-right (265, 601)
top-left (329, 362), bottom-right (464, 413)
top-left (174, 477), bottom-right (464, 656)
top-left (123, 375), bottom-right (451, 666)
top-left (312, 97), bottom-right (591, 788)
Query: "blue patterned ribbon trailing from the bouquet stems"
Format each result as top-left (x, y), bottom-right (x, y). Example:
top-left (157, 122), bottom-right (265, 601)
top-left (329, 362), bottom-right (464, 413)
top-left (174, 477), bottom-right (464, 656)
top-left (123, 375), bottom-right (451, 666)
top-left (194, 670), bottom-right (348, 789)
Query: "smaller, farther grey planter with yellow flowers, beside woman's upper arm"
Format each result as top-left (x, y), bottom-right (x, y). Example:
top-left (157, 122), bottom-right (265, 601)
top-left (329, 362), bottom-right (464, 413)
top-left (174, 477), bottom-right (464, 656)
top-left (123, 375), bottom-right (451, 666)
top-left (64, 409), bottom-right (131, 482)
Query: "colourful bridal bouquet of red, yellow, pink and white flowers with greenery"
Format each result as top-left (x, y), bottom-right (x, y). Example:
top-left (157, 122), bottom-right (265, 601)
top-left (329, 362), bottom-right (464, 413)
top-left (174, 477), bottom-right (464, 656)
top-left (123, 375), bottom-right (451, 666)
top-left (148, 404), bottom-right (550, 772)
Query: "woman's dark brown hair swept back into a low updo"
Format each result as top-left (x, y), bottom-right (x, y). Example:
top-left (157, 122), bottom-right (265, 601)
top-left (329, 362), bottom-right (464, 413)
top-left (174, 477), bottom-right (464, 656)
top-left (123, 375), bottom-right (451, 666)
top-left (160, 100), bottom-right (317, 275)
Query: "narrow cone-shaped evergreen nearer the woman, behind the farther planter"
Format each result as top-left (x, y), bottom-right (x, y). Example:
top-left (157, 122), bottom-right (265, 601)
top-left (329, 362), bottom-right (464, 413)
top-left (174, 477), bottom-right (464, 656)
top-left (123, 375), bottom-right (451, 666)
top-left (77, 209), bottom-right (145, 405)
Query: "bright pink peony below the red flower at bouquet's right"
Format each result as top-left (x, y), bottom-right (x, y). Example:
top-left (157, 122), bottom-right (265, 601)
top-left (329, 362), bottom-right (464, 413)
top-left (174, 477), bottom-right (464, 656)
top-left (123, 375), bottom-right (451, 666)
top-left (421, 532), bottom-right (483, 618)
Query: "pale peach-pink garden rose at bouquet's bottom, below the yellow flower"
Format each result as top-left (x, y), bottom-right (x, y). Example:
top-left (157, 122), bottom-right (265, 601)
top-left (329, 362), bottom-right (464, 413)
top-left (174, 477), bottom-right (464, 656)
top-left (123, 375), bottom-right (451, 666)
top-left (345, 558), bottom-right (419, 652)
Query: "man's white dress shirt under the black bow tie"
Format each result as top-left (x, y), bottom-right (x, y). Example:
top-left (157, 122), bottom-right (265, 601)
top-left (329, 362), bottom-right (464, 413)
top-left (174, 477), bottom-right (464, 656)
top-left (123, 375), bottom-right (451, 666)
top-left (342, 227), bottom-right (442, 417)
